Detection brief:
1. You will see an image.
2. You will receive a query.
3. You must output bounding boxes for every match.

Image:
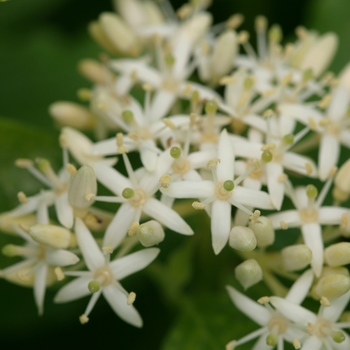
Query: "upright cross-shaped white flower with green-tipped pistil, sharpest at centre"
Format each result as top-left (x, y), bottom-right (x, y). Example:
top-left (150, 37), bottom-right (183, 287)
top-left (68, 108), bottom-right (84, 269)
top-left (161, 129), bottom-right (273, 254)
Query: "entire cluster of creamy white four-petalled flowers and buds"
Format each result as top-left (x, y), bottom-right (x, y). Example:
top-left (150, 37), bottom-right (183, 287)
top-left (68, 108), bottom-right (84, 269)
top-left (0, 0), bottom-right (350, 350)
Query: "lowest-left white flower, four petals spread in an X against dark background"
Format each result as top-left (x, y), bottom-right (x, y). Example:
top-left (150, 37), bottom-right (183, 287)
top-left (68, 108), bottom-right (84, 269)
top-left (55, 218), bottom-right (159, 327)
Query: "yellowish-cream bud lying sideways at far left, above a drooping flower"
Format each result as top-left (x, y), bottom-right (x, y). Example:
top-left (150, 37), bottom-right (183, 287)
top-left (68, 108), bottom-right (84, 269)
top-left (29, 224), bottom-right (71, 249)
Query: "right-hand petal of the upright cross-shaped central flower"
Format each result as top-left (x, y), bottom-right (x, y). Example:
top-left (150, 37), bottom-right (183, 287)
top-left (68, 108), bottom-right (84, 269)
top-left (231, 186), bottom-right (275, 209)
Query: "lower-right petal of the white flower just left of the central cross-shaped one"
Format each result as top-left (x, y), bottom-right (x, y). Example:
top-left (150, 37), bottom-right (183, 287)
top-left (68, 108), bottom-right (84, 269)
top-left (143, 198), bottom-right (193, 235)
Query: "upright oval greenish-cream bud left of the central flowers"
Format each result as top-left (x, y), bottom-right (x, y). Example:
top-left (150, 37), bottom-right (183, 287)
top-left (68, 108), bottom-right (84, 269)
top-left (68, 165), bottom-right (97, 209)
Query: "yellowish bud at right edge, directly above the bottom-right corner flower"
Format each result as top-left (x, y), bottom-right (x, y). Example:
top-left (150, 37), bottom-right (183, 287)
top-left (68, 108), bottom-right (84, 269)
top-left (315, 274), bottom-right (350, 300)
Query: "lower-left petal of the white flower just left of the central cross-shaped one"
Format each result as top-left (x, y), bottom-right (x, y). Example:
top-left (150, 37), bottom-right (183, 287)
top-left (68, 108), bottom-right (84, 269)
top-left (103, 203), bottom-right (137, 249)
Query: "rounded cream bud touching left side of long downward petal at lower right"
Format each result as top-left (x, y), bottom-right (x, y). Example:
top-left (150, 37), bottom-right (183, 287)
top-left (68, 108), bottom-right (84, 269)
top-left (281, 244), bottom-right (312, 271)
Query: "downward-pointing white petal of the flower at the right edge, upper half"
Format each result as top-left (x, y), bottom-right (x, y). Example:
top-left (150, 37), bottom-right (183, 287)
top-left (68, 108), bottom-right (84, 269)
top-left (318, 134), bottom-right (340, 181)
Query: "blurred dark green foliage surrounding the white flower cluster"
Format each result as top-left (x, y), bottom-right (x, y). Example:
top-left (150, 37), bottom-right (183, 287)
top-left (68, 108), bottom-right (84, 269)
top-left (0, 0), bottom-right (350, 350)
